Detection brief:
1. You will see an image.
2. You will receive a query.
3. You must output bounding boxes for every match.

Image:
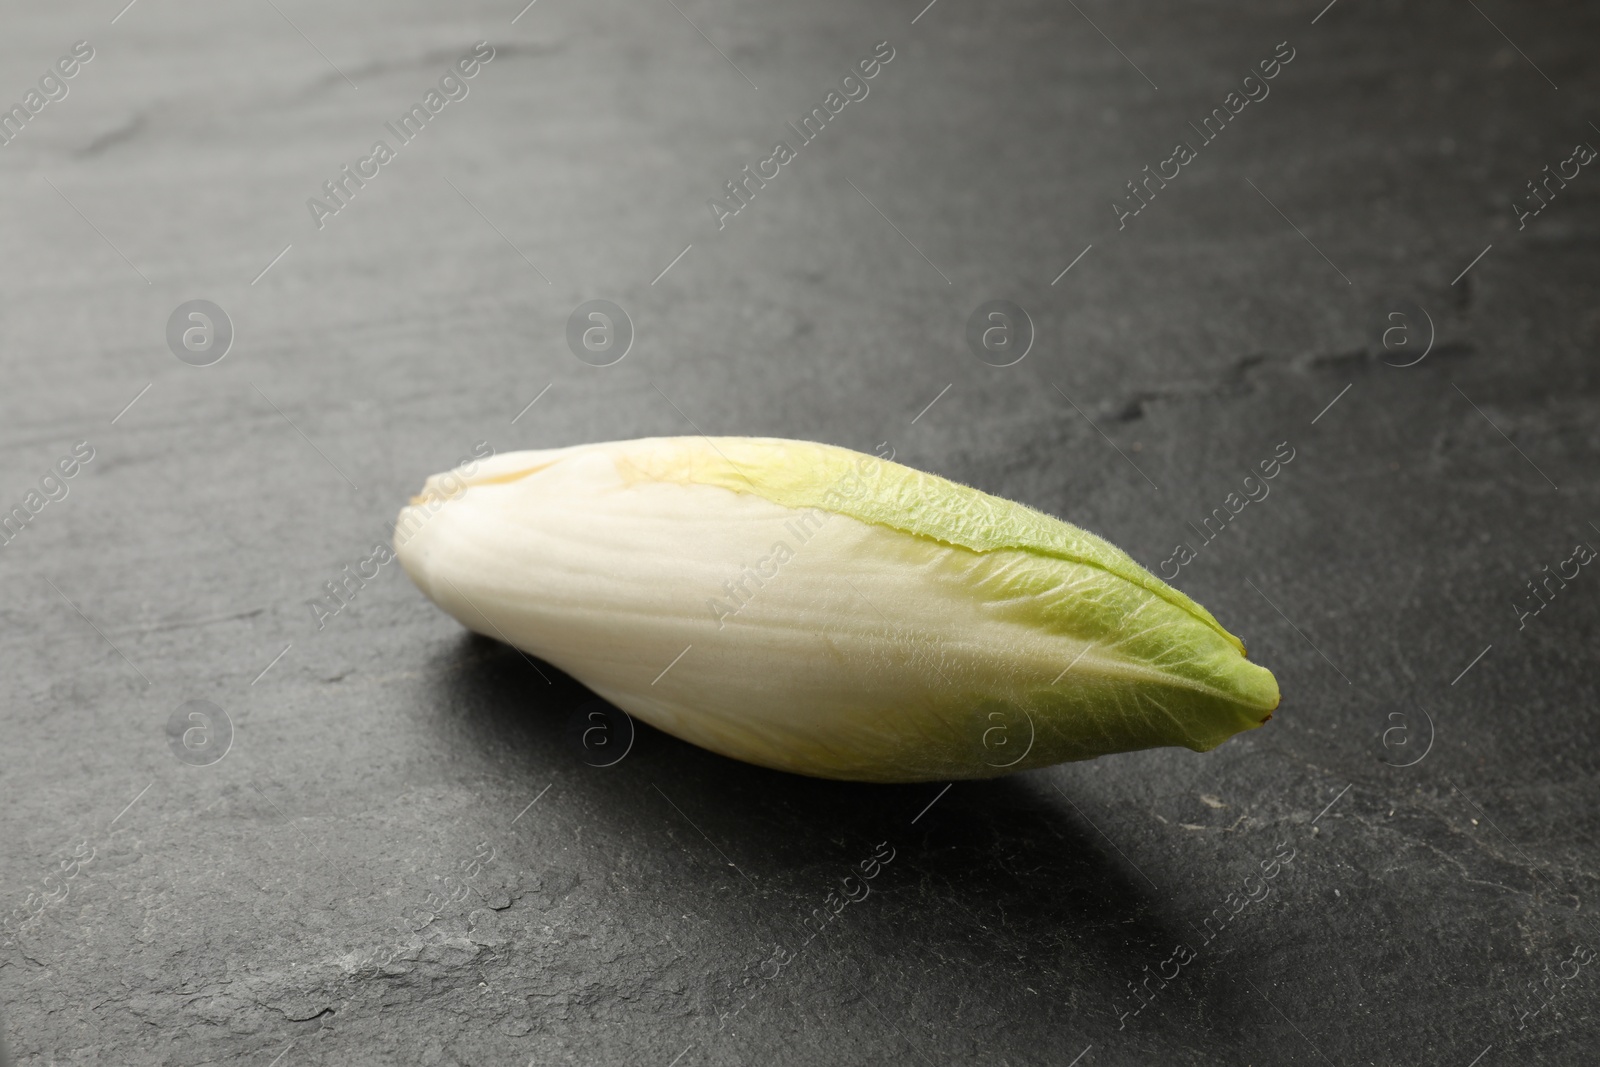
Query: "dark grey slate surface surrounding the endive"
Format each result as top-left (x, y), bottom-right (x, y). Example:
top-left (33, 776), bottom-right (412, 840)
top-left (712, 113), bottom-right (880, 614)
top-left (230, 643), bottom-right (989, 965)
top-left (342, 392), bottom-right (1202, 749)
top-left (0, 0), bottom-right (1600, 1067)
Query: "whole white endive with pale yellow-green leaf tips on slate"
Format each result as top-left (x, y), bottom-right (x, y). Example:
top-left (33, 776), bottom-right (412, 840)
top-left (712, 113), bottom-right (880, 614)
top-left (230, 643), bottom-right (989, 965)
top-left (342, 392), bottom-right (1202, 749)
top-left (395, 437), bottom-right (1278, 782)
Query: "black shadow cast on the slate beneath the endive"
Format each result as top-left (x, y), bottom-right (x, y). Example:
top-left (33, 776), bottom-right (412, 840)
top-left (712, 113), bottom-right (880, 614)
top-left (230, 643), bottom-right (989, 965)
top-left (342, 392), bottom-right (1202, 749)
top-left (429, 635), bottom-right (1266, 1059)
